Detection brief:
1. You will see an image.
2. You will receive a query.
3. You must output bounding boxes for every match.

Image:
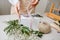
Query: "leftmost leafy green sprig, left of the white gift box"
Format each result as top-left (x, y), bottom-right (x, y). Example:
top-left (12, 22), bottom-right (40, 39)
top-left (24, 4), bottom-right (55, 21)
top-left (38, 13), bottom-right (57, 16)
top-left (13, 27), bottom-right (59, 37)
top-left (4, 20), bottom-right (20, 34)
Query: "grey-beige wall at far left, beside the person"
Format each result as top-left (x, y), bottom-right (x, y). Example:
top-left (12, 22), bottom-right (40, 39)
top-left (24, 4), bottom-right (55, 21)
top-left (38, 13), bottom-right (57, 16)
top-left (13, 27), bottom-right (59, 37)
top-left (0, 0), bottom-right (10, 15)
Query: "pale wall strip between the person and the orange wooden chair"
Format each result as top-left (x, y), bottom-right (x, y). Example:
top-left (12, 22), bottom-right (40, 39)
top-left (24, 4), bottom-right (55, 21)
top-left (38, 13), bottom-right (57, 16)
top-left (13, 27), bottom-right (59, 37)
top-left (36, 0), bottom-right (49, 14)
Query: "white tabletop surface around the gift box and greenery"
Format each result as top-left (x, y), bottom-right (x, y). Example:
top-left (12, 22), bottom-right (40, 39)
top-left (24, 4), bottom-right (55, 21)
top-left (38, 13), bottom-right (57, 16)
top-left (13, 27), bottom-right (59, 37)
top-left (0, 15), bottom-right (60, 40)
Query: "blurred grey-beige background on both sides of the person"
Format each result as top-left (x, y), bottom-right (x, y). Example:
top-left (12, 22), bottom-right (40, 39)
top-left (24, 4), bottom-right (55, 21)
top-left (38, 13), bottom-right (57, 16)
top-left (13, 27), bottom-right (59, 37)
top-left (0, 0), bottom-right (60, 15)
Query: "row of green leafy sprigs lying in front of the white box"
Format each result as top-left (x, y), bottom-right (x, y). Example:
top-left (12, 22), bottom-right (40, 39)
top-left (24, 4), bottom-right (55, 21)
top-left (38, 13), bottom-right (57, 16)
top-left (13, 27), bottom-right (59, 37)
top-left (4, 20), bottom-right (43, 37)
